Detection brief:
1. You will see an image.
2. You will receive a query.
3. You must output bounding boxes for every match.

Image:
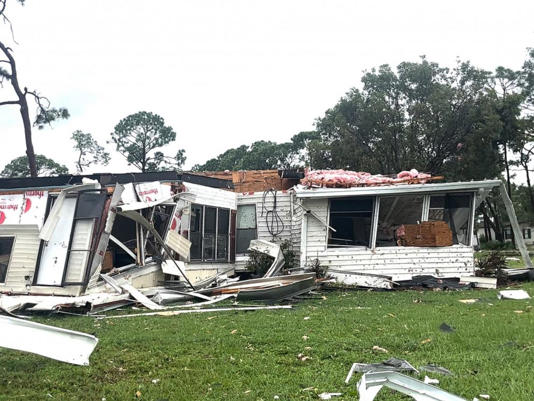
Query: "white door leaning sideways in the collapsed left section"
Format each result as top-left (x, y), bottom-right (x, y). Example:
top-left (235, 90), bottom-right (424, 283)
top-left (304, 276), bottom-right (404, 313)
top-left (37, 198), bottom-right (76, 285)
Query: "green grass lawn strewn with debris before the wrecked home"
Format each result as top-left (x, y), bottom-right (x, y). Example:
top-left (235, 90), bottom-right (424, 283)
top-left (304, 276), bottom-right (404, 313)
top-left (0, 283), bottom-right (534, 401)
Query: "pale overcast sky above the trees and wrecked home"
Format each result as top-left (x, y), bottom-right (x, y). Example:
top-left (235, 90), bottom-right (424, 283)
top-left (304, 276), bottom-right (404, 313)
top-left (0, 0), bottom-right (534, 172)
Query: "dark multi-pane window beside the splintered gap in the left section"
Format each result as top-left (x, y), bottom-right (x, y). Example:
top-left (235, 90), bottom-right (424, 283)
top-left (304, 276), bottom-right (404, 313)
top-left (189, 205), bottom-right (230, 261)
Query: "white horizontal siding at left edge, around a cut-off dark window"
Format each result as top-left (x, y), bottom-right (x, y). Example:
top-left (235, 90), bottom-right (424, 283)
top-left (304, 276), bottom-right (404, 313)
top-left (0, 225), bottom-right (41, 291)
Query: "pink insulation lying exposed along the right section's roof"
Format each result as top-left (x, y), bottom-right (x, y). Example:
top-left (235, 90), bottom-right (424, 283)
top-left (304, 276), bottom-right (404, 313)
top-left (302, 169), bottom-right (431, 187)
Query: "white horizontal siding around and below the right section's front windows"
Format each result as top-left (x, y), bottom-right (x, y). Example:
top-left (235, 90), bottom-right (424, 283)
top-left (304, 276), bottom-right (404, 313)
top-left (304, 199), bottom-right (474, 280)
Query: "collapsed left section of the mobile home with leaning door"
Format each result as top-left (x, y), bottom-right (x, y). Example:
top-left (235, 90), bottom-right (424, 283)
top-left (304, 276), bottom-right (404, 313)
top-left (0, 172), bottom-right (236, 296)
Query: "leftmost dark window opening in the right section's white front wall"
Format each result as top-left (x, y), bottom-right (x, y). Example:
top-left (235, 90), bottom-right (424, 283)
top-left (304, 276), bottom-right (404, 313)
top-left (328, 197), bottom-right (374, 247)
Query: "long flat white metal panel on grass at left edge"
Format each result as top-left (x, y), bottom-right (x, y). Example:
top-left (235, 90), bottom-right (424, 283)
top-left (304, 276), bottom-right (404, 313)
top-left (0, 316), bottom-right (98, 365)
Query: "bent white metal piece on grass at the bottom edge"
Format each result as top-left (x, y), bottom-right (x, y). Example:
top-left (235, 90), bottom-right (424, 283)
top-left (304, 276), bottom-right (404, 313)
top-left (358, 371), bottom-right (467, 401)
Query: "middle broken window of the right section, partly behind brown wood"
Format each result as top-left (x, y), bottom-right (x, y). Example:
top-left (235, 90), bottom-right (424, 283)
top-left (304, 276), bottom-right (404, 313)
top-left (376, 195), bottom-right (423, 247)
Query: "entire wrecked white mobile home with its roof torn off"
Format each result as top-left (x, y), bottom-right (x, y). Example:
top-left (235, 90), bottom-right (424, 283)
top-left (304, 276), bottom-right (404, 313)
top-left (0, 170), bottom-right (531, 310)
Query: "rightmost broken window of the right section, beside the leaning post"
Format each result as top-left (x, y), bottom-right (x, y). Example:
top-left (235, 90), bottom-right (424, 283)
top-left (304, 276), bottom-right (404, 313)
top-left (428, 193), bottom-right (472, 245)
